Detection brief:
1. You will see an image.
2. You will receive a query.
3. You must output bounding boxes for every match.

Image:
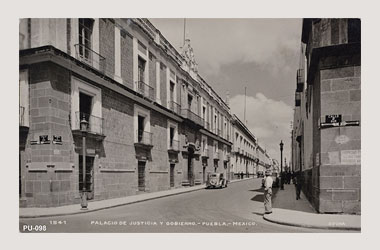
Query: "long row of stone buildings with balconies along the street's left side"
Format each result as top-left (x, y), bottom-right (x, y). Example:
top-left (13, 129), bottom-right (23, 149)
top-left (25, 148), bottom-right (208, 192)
top-left (19, 18), bottom-right (272, 207)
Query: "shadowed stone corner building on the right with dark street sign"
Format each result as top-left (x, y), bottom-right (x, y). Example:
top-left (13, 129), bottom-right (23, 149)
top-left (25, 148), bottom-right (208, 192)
top-left (292, 19), bottom-right (361, 213)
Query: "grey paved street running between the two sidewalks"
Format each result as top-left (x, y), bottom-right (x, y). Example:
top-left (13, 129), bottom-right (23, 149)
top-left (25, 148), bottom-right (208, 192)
top-left (20, 179), bottom-right (337, 233)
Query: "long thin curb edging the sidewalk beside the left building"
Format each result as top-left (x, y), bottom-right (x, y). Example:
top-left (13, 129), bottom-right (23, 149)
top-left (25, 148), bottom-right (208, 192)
top-left (19, 178), bottom-right (252, 219)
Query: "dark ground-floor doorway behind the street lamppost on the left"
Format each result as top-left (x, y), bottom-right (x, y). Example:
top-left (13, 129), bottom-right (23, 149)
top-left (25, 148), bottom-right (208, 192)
top-left (79, 155), bottom-right (94, 200)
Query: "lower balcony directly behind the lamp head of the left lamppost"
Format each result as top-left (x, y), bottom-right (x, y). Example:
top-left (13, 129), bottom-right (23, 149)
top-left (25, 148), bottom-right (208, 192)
top-left (72, 111), bottom-right (105, 140)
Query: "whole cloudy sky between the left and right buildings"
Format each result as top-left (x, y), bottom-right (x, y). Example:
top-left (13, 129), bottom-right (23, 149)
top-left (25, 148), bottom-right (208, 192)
top-left (150, 18), bottom-right (302, 165)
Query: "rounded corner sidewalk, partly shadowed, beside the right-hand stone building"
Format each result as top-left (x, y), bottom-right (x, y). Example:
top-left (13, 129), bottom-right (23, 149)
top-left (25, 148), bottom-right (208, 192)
top-left (264, 184), bottom-right (361, 231)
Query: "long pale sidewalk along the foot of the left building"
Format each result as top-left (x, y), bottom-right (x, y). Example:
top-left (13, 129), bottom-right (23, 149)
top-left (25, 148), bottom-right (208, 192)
top-left (19, 178), bottom-right (252, 218)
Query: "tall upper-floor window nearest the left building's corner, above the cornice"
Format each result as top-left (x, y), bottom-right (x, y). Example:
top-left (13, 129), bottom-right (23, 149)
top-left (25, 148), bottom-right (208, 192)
top-left (79, 18), bottom-right (94, 60)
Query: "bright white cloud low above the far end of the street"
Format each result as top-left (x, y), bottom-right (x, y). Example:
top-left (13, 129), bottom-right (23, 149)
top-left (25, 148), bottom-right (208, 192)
top-left (230, 93), bottom-right (293, 161)
